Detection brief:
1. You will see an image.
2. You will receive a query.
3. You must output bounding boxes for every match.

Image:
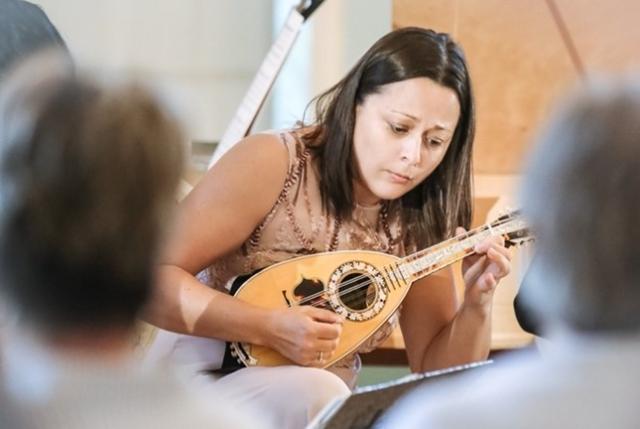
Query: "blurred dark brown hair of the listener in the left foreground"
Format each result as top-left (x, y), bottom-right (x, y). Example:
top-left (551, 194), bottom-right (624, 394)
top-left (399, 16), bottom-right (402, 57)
top-left (0, 53), bottom-right (184, 334)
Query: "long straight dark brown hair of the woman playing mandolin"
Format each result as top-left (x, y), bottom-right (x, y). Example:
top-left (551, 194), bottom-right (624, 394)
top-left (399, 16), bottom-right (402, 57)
top-left (303, 27), bottom-right (475, 247)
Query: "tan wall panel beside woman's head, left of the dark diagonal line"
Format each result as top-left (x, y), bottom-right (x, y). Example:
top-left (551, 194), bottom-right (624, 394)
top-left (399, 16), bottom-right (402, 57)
top-left (393, 0), bottom-right (578, 174)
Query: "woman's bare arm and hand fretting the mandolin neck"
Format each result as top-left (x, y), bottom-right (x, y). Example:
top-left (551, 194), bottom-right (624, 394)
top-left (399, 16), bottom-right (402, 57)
top-left (400, 237), bottom-right (510, 372)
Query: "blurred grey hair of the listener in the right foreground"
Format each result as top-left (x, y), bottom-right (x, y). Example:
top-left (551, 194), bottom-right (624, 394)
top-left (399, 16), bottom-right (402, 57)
top-left (521, 79), bottom-right (640, 333)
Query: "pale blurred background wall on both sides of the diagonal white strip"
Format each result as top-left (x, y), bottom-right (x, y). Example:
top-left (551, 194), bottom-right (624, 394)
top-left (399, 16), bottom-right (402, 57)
top-left (33, 0), bottom-right (391, 154)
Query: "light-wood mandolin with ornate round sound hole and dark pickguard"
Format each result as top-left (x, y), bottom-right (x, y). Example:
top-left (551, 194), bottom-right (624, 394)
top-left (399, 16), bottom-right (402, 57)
top-left (221, 211), bottom-right (533, 371)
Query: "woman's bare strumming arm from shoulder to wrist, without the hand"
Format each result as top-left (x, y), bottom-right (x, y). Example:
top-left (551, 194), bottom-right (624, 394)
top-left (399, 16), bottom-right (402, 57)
top-left (146, 135), bottom-right (288, 340)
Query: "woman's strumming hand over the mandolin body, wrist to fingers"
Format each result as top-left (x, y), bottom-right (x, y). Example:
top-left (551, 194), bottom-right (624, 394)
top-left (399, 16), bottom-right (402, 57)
top-left (266, 305), bottom-right (343, 367)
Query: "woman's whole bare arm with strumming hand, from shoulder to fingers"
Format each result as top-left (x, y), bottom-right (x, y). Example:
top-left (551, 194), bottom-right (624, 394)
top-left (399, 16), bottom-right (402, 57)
top-left (146, 135), bottom-right (341, 364)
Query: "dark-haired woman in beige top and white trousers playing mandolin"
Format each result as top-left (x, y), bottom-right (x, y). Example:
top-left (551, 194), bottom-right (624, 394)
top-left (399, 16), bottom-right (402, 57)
top-left (145, 28), bottom-right (510, 427)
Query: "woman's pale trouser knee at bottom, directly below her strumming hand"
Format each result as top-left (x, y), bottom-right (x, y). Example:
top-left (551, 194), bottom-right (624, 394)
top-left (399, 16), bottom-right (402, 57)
top-left (194, 366), bottom-right (351, 429)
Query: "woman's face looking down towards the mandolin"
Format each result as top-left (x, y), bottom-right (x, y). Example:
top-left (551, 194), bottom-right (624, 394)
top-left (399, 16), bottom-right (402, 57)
top-left (353, 77), bottom-right (460, 205)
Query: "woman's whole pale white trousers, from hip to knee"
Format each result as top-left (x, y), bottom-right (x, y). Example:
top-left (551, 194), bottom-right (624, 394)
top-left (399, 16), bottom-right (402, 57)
top-left (145, 330), bottom-right (357, 429)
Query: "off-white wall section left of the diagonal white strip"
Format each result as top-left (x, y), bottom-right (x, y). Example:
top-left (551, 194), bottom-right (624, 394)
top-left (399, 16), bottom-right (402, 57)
top-left (36, 0), bottom-right (272, 144)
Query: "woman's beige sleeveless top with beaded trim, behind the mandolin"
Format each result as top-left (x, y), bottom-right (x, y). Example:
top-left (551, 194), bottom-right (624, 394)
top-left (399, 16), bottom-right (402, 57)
top-left (198, 132), bottom-right (406, 382)
